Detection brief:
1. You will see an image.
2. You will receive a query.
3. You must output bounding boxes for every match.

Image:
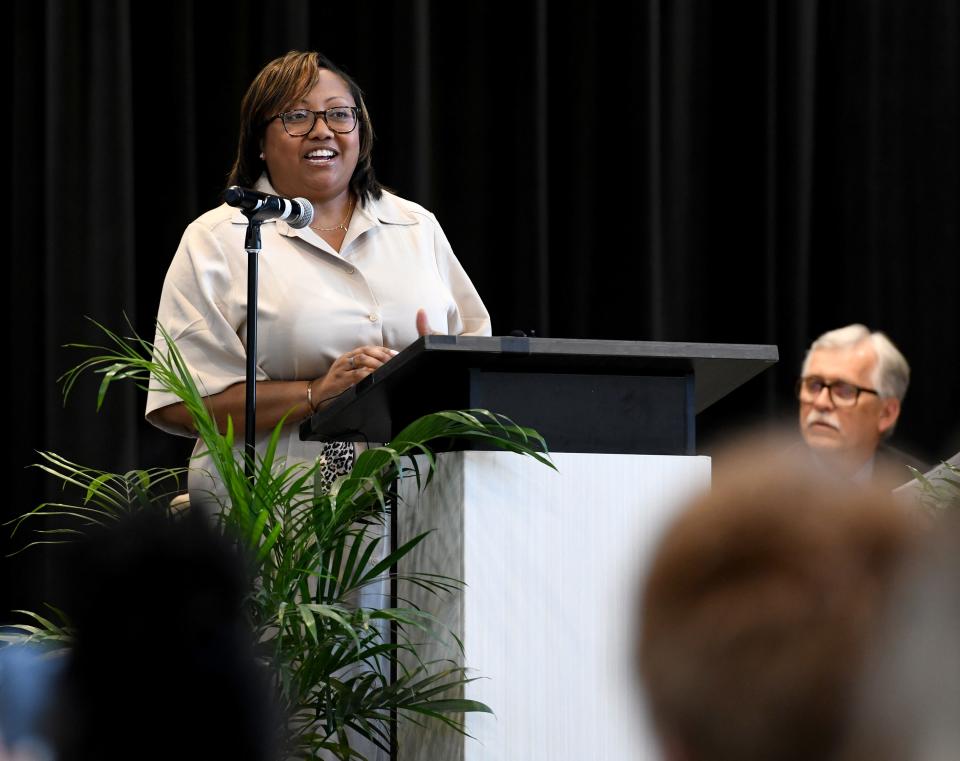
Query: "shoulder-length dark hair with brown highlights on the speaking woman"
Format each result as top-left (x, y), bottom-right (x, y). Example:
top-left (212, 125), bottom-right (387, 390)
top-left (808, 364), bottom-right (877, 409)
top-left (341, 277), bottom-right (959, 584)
top-left (227, 50), bottom-right (383, 205)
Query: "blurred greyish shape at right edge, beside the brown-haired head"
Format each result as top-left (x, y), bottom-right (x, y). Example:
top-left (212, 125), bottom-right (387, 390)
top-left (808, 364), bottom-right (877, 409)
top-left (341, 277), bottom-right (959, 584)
top-left (843, 504), bottom-right (960, 761)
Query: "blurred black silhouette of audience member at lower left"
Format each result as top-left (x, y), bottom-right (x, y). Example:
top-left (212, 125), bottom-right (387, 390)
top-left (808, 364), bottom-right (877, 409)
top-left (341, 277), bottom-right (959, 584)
top-left (49, 511), bottom-right (281, 761)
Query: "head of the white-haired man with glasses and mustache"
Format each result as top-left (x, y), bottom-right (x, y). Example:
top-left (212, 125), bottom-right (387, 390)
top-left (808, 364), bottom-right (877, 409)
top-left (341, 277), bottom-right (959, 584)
top-left (797, 325), bottom-right (922, 486)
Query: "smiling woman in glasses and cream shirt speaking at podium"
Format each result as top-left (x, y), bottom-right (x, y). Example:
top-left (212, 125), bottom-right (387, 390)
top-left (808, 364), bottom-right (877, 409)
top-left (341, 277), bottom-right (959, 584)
top-left (147, 52), bottom-right (490, 501)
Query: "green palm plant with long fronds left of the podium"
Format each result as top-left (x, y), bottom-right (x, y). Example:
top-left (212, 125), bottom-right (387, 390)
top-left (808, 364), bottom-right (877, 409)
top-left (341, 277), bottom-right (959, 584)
top-left (7, 318), bottom-right (552, 759)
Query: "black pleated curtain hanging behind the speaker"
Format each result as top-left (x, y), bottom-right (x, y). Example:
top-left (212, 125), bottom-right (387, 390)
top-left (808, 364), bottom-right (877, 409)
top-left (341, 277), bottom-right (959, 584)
top-left (7, 0), bottom-right (960, 610)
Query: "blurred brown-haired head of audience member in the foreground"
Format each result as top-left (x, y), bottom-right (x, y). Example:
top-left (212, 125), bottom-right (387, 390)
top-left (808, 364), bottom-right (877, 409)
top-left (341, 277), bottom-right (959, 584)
top-left (638, 448), bottom-right (916, 761)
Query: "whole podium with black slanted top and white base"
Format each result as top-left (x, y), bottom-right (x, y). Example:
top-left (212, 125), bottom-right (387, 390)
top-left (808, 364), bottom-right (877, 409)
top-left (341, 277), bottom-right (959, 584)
top-left (301, 336), bottom-right (777, 761)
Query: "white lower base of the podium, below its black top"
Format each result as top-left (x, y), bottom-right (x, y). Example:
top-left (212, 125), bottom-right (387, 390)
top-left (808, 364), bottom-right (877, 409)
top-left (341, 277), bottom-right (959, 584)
top-left (397, 452), bottom-right (710, 761)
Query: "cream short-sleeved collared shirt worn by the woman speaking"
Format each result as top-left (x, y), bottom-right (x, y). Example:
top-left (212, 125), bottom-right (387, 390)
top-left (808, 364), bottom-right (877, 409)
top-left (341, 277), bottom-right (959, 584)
top-left (146, 177), bottom-right (490, 502)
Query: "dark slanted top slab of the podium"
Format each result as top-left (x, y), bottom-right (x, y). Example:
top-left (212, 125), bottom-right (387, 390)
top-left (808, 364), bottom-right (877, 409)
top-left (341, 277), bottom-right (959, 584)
top-left (300, 335), bottom-right (779, 439)
